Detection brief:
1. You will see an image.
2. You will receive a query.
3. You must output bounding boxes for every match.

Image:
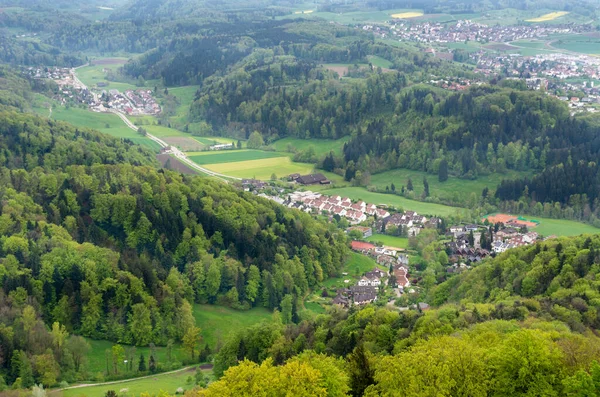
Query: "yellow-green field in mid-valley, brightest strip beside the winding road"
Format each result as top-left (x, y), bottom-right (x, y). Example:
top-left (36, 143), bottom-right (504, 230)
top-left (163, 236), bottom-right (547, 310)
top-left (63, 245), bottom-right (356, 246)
top-left (202, 157), bottom-right (313, 180)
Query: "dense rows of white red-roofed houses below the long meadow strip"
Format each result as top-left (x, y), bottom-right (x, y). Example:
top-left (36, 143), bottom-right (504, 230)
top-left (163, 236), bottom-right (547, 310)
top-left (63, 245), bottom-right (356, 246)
top-left (286, 191), bottom-right (390, 224)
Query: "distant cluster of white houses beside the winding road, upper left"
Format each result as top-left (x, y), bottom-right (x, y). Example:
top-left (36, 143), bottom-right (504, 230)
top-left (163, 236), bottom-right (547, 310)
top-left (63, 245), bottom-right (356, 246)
top-left (98, 89), bottom-right (161, 116)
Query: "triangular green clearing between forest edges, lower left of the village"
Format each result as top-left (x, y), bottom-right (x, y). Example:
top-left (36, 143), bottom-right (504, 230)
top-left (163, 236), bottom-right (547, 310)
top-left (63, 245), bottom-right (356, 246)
top-left (194, 305), bottom-right (272, 348)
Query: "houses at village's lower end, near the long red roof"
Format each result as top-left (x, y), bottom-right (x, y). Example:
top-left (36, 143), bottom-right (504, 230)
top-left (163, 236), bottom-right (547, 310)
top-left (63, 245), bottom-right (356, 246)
top-left (333, 241), bottom-right (414, 307)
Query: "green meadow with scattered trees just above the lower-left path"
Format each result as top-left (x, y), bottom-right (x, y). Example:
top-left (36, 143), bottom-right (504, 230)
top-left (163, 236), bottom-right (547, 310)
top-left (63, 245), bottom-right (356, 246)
top-left (87, 339), bottom-right (187, 379)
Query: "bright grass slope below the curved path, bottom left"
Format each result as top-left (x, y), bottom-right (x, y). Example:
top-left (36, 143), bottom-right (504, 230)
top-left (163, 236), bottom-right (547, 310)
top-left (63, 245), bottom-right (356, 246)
top-left (59, 369), bottom-right (211, 397)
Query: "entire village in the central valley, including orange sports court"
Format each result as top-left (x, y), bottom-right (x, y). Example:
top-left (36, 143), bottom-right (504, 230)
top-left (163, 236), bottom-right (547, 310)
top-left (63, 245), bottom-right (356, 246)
top-left (241, 174), bottom-right (554, 310)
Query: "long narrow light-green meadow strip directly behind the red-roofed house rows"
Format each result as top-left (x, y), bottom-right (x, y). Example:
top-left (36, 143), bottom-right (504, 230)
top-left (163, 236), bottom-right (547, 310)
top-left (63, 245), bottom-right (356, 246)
top-left (323, 187), bottom-right (468, 216)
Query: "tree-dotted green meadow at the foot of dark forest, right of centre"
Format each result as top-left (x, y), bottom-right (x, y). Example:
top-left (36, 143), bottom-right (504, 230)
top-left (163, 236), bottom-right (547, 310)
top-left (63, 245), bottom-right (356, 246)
top-left (370, 169), bottom-right (530, 203)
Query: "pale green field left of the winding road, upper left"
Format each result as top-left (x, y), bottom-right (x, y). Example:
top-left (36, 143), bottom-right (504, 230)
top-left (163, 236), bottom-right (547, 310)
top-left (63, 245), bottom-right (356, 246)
top-left (52, 107), bottom-right (160, 152)
